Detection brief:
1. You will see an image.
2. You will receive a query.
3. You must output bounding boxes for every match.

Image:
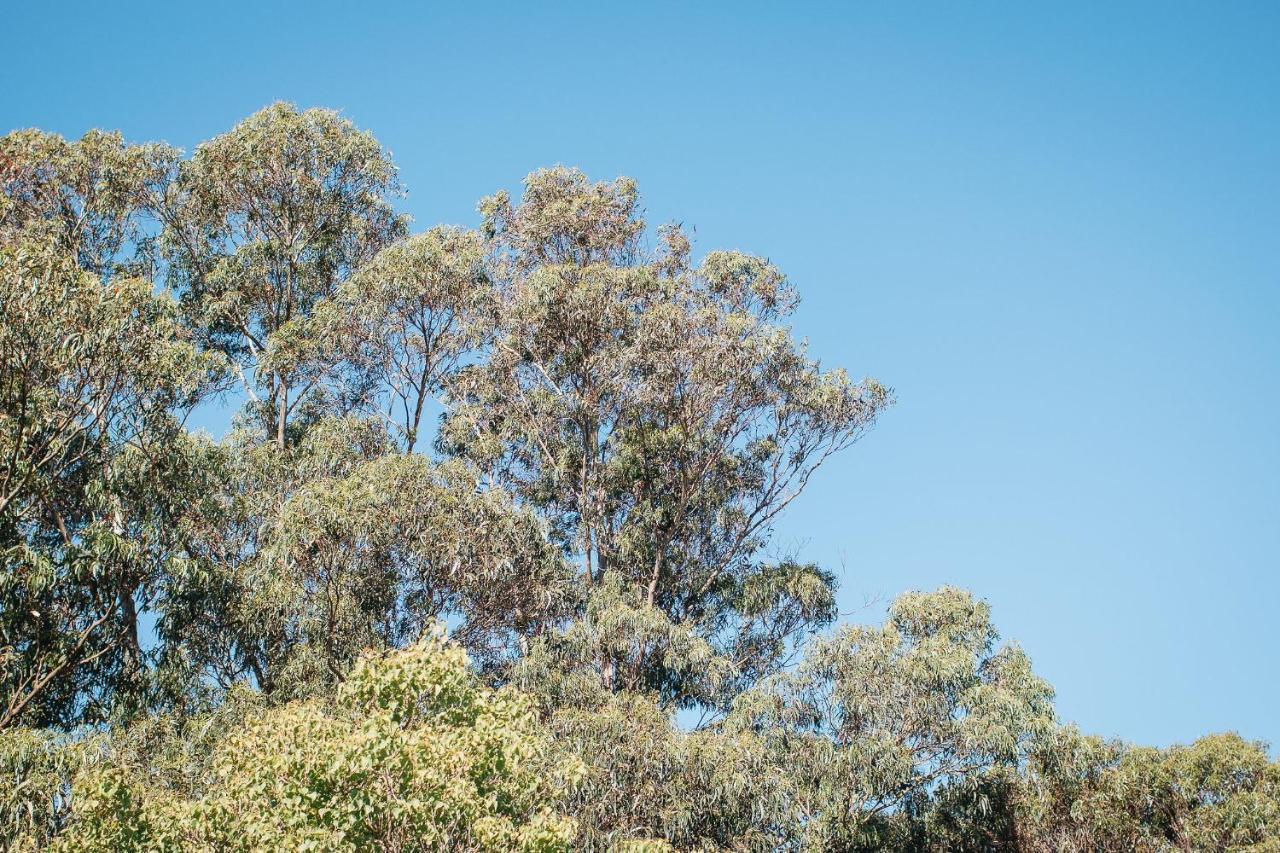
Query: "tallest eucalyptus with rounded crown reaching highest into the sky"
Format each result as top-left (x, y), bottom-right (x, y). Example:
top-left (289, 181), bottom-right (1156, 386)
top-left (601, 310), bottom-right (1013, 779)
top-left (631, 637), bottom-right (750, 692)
top-left (163, 104), bottom-right (406, 447)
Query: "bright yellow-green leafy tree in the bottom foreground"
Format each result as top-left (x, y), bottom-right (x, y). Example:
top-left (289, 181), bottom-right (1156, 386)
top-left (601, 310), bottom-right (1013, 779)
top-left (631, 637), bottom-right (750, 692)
top-left (59, 631), bottom-right (579, 852)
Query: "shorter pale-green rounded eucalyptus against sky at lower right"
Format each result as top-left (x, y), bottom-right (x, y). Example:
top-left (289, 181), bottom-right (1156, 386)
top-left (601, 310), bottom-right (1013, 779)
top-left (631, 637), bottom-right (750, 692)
top-left (726, 587), bottom-right (1053, 849)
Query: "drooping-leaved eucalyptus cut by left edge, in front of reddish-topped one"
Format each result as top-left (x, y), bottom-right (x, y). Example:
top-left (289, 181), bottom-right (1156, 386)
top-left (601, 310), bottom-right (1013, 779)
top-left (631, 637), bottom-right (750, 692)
top-left (0, 237), bottom-right (219, 726)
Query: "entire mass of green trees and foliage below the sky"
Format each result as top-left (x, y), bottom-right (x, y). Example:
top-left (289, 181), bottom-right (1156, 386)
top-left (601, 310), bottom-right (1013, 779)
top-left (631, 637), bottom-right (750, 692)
top-left (0, 104), bottom-right (1280, 852)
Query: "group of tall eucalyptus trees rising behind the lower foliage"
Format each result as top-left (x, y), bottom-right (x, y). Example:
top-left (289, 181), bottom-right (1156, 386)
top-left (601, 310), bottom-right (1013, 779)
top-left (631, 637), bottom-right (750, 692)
top-left (0, 105), bottom-right (890, 724)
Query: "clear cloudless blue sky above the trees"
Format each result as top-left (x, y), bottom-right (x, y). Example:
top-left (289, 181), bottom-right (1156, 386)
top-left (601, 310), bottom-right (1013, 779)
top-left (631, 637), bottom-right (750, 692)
top-left (0, 0), bottom-right (1280, 744)
